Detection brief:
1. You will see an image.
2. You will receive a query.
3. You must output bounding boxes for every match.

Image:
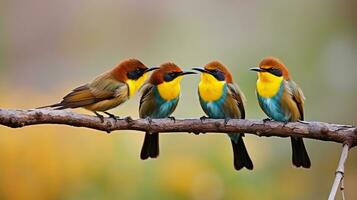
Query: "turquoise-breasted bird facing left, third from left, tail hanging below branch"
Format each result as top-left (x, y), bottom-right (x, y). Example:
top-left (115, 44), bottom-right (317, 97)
top-left (193, 61), bottom-right (253, 170)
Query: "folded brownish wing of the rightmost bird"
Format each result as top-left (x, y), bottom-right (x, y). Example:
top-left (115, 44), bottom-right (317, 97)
top-left (285, 80), bottom-right (305, 120)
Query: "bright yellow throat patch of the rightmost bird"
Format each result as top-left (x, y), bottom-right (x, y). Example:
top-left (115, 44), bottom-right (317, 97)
top-left (257, 72), bottom-right (284, 98)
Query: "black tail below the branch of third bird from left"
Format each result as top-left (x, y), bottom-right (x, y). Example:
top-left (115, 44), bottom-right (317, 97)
top-left (231, 136), bottom-right (253, 170)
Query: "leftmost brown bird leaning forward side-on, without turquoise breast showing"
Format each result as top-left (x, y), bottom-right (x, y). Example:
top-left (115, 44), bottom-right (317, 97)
top-left (39, 58), bottom-right (158, 122)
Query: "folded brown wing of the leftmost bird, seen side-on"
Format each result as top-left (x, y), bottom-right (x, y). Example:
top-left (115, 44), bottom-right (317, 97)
top-left (59, 74), bottom-right (128, 108)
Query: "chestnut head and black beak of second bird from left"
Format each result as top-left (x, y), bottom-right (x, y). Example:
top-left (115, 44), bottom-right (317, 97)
top-left (149, 62), bottom-right (195, 85)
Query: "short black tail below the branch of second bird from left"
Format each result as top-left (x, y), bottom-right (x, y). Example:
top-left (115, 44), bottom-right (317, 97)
top-left (140, 132), bottom-right (159, 160)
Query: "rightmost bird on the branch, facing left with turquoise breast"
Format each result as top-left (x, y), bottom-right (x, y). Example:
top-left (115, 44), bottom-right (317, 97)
top-left (250, 56), bottom-right (311, 168)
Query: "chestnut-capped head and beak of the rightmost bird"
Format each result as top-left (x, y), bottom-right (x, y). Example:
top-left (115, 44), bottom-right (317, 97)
top-left (250, 56), bottom-right (290, 82)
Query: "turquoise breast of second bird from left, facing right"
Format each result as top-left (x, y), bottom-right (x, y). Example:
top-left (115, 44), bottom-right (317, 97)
top-left (150, 87), bottom-right (179, 118)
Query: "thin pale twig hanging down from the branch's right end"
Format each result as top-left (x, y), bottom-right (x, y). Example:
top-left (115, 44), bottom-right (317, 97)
top-left (328, 144), bottom-right (349, 200)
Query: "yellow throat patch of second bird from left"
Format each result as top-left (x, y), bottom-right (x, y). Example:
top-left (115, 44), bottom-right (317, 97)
top-left (157, 76), bottom-right (182, 101)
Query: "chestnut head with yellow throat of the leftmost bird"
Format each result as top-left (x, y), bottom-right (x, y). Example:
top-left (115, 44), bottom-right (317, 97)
top-left (111, 58), bottom-right (158, 96)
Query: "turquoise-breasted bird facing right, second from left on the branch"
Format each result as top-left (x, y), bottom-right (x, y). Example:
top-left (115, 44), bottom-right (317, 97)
top-left (139, 62), bottom-right (195, 160)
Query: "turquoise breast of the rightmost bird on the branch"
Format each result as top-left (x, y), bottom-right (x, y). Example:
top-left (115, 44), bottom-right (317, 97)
top-left (257, 83), bottom-right (291, 122)
